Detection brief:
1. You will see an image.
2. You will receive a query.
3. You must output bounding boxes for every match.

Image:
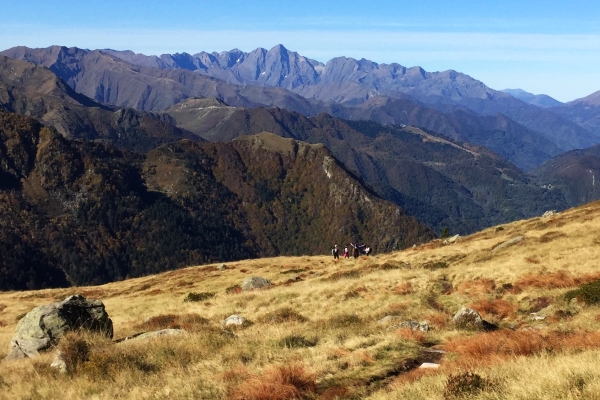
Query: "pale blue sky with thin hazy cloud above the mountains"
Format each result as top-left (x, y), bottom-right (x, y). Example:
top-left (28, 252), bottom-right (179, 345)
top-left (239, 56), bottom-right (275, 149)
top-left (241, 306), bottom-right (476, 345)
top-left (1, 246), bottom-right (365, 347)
top-left (0, 0), bottom-right (600, 101)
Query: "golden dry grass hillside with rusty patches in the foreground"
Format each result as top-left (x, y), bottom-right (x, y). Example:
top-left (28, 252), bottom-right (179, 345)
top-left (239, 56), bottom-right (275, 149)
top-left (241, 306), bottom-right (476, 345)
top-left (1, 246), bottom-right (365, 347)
top-left (0, 202), bottom-right (600, 399)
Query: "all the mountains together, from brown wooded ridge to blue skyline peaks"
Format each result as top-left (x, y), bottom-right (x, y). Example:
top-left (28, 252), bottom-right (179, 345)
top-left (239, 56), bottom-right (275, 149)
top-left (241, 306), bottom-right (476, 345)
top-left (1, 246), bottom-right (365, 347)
top-left (0, 46), bottom-right (600, 289)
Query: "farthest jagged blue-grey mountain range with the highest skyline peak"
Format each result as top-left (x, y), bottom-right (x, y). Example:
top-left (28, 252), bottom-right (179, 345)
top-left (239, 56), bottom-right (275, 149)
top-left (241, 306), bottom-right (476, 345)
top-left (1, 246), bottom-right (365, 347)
top-left (96, 45), bottom-right (600, 150)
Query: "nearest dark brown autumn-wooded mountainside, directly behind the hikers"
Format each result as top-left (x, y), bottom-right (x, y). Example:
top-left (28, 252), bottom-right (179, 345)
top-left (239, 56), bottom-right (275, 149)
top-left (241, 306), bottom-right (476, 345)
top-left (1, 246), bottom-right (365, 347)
top-left (0, 112), bottom-right (434, 290)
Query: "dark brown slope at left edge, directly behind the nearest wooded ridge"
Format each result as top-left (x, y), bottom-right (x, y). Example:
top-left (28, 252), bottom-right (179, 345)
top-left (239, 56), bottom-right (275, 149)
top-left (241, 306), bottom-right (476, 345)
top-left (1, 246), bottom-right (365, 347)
top-left (0, 56), bottom-right (195, 151)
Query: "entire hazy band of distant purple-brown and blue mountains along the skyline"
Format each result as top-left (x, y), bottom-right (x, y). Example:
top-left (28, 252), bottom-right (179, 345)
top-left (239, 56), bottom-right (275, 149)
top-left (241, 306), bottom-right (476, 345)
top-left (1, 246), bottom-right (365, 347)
top-left (2, 46), bottom-right (600, 170)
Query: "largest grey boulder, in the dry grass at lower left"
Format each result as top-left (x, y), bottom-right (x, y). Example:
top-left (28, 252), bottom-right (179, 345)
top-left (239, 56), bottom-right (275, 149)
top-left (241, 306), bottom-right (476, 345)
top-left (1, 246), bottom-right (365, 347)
top-left (5, 295), bottom-right (113, 360)
